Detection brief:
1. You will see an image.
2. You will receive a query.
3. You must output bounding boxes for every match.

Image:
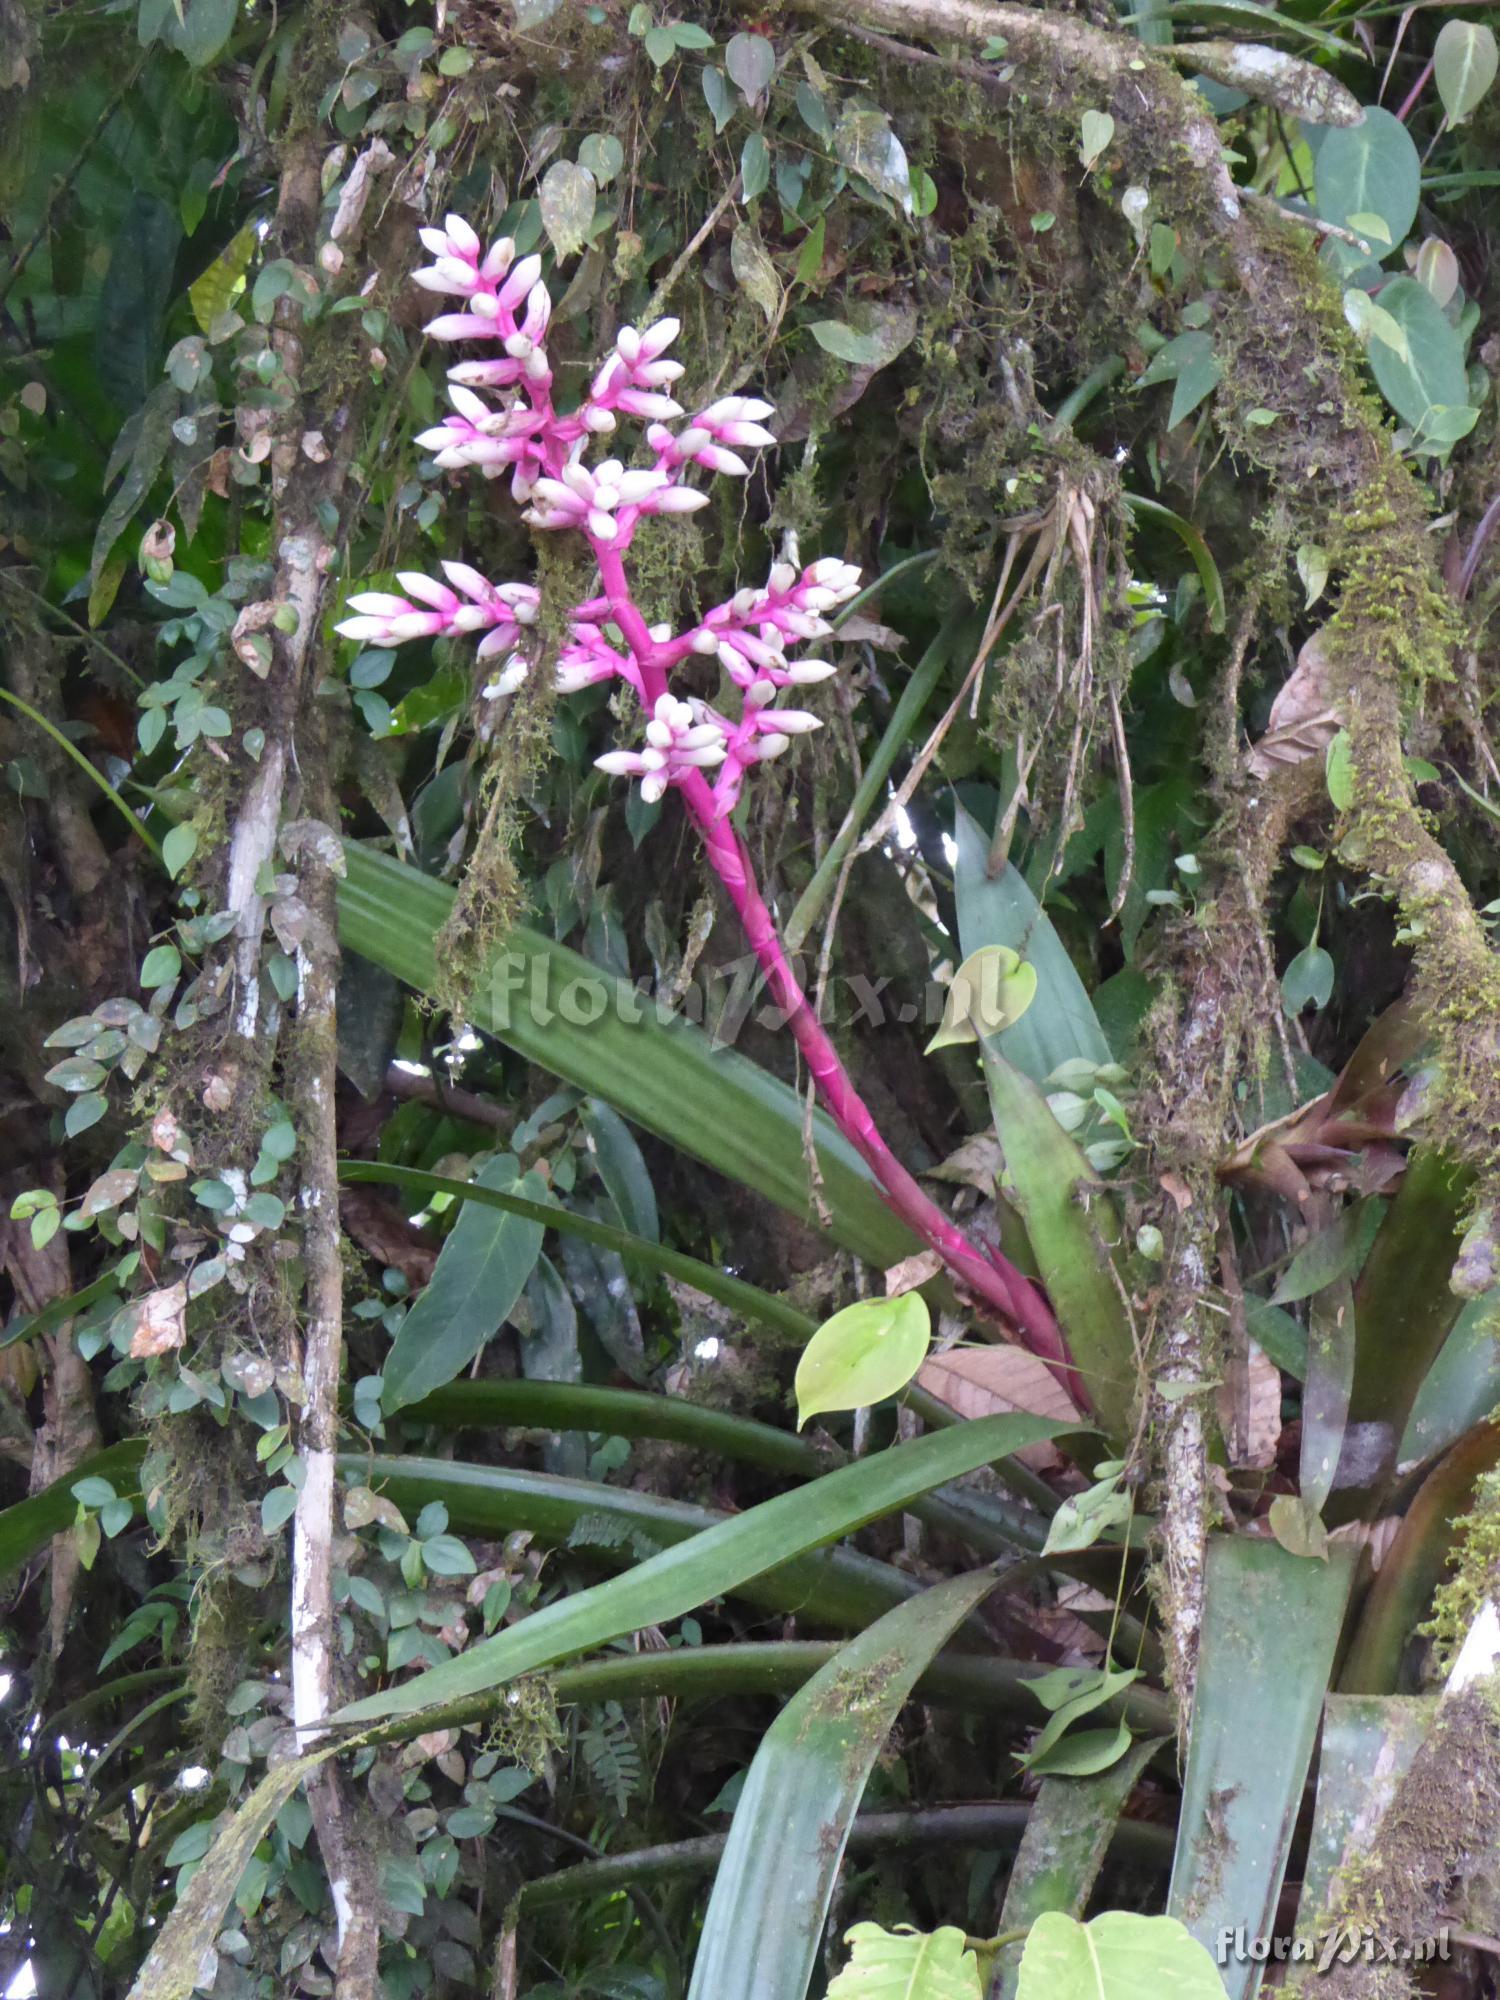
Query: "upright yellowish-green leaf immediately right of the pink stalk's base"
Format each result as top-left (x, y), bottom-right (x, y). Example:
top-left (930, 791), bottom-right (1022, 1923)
top-left (980, 1056), bottom-right (1136, 1440)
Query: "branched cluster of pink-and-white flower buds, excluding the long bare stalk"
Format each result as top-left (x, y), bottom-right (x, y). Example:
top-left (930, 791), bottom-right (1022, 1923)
top-left (336, 216), bottom-right (860, 816)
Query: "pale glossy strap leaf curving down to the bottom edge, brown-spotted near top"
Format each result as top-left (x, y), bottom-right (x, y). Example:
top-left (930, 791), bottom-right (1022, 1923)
top-left (688, 1570), bottom-right (996, 2000)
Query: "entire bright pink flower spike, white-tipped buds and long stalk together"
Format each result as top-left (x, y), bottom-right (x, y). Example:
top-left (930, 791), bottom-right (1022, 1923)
top-left (336, 216), bottom-right (1078, 1394)
